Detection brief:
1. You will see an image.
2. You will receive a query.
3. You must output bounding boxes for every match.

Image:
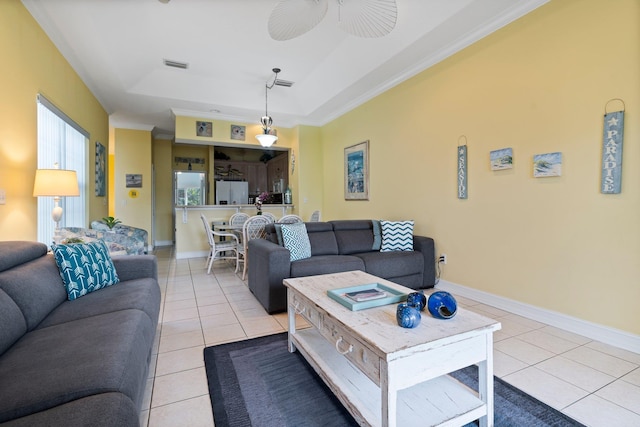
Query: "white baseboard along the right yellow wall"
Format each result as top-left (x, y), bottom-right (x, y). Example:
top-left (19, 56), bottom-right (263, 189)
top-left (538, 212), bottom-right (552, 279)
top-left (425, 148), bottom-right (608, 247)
top-left (436, 280), bottom-right (640, 353)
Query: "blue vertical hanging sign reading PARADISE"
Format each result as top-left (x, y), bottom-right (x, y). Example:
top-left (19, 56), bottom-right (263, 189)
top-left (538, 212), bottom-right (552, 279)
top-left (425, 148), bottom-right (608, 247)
top-left (600, 111), bottom-right (624, 194)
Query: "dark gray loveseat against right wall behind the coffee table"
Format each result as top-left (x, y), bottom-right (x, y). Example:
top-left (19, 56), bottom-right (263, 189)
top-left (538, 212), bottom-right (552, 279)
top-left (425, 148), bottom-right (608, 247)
top-left (248, 220), bottom-right (435, 313)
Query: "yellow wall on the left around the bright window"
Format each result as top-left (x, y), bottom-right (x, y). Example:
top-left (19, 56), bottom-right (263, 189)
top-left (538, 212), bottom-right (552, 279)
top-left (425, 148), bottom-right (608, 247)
top-left (0, 0), bottom-right (108, 240)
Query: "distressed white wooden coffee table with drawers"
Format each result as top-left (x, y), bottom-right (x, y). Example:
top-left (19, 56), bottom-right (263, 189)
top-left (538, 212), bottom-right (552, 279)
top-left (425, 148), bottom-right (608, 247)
top-left (284, 271), bottom-right (501, 427)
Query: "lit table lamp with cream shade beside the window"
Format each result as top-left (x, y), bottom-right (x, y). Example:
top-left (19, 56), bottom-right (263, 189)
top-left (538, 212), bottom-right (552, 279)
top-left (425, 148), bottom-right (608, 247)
top-left (33, 169), bottom-right (80, 243)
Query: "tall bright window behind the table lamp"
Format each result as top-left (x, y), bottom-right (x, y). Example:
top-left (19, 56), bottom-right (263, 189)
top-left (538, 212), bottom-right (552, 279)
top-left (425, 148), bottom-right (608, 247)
top-left (37, 95), bottom-right (89, 245)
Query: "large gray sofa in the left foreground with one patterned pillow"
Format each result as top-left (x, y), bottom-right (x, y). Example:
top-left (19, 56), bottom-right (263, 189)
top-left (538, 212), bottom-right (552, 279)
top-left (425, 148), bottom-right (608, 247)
top-left (0, 242), bottom-right (160, 427)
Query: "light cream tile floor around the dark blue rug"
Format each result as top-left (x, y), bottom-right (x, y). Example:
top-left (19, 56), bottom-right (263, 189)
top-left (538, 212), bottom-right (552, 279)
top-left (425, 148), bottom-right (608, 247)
top-left (140, 247), bottom-right (640, 427)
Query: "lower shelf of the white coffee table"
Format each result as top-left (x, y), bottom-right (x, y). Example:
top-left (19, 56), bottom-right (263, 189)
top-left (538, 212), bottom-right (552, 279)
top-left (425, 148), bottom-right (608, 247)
top-left (289, 328), bottom-right (487, 426)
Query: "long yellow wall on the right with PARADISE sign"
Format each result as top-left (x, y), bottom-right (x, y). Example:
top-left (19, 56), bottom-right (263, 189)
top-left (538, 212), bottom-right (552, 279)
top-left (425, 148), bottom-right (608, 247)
top-left (322, 0), bottom-right (640, 334)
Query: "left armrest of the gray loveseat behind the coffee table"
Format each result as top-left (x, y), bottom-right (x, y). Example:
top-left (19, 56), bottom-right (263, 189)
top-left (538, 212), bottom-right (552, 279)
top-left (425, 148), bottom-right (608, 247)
top-left (246, 239), bottom-right (291, 314)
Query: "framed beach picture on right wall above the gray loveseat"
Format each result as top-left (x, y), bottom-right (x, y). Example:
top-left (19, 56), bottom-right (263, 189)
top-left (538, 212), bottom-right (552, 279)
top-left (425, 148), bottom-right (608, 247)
top-left (344, 141), bottom-right (369, 200)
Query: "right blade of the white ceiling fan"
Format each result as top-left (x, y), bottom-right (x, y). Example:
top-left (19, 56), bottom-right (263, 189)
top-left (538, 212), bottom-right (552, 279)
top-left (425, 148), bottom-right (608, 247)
top-left (338, 0), bottom-right (398, 38)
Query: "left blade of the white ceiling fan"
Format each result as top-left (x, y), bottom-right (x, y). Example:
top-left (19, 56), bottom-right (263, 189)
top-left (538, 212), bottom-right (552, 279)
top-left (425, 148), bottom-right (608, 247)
top-left (268, 0), bottom-right (328, 41)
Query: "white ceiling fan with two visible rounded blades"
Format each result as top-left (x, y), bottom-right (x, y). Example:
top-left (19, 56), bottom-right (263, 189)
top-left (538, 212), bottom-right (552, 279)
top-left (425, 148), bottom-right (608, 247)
top-left (268, 0), bottom-right (398, 41)
